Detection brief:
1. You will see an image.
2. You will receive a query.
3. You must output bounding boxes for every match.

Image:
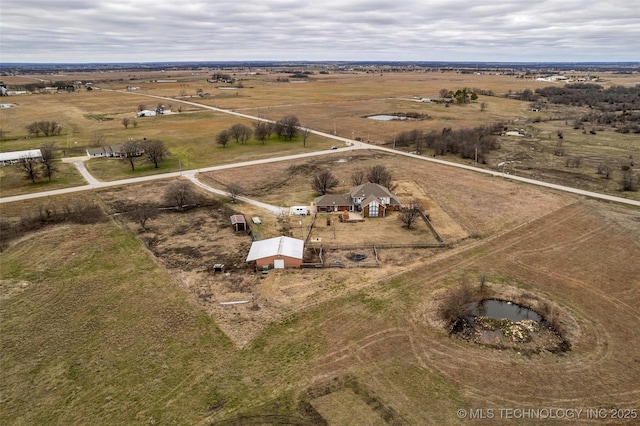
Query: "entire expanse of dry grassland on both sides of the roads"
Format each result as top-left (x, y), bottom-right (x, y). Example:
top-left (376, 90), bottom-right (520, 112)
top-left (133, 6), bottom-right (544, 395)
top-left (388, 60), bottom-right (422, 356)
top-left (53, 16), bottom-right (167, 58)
top-left (0, 65), bottom-right (640, 425)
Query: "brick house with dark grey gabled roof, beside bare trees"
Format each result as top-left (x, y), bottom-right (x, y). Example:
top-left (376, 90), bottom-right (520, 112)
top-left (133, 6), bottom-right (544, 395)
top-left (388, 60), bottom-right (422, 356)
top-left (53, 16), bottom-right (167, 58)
top-left (314, 182), bottom-right (401, 217)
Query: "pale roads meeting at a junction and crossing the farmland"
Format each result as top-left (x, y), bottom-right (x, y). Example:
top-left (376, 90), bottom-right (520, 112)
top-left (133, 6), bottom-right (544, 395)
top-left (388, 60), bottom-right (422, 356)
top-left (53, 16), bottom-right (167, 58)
top-left (0, 89), bottom-right (640, 211)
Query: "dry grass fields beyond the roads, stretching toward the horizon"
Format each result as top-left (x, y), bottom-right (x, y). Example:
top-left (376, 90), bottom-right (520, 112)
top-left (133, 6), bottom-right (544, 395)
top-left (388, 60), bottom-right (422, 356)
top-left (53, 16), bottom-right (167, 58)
top-left (0, 69), bottom-right (640, 203)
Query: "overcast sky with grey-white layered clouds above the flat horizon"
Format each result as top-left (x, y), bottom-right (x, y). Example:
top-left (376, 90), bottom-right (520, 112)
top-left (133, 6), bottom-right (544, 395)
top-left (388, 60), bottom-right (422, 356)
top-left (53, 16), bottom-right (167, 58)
top-left (0, 0), bottom-right (640, 63)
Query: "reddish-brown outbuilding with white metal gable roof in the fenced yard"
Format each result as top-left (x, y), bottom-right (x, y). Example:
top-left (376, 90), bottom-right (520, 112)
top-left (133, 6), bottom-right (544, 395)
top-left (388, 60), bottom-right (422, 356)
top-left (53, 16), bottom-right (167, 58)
top-left (247, 236), bottom-right (304, 269)
